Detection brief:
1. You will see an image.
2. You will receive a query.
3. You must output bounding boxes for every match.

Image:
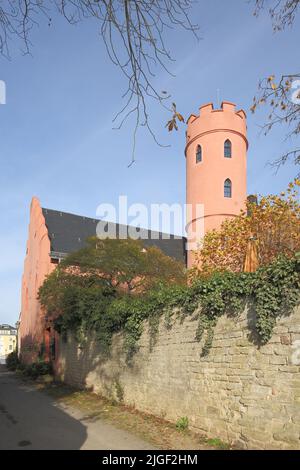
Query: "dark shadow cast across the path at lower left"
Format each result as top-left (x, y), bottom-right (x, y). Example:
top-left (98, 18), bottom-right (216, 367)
top-left (0, 365), bottom-right (87, 450)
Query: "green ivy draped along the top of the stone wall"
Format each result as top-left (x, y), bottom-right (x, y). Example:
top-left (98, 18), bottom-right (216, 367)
top-left (40, 253), bottom-right (300, 361)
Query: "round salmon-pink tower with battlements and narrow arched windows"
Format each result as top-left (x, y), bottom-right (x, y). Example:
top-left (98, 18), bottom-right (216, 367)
top-left (185, 101), bottom-right (248, 268)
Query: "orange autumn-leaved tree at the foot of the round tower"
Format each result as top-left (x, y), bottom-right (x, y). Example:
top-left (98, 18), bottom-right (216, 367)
top-left (190, 179), bottom-right (300, 278)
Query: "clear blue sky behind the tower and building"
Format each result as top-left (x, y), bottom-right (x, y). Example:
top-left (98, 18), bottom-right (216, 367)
top-left (0, 0), bottom-right (300, 323)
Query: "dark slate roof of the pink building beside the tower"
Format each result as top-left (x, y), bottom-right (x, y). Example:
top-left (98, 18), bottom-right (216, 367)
top-left (42, 208), bottom-right (186, 263)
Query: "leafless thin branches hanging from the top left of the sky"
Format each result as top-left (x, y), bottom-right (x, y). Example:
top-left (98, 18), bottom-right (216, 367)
top-left (0, 0), bottom-right (198, 163)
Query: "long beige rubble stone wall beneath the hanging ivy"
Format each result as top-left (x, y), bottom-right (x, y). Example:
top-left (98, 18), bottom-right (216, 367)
top-left (57, 308), bottom-right (300, 449)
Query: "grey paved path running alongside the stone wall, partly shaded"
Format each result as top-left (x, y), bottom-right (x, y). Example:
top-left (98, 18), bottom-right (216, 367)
top-left (0, 365), bottom-right (153, 450)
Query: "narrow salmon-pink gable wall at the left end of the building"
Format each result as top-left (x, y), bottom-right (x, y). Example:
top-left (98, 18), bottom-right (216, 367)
top-left (19, 197), bottom-right (55, 362)
